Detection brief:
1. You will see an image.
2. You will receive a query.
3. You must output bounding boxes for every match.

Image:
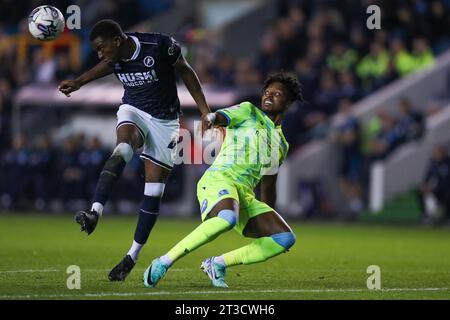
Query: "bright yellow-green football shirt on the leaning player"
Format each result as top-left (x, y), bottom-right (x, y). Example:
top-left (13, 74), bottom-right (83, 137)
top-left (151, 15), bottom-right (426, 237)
top-left (208, 102), bottom-right (289, 190)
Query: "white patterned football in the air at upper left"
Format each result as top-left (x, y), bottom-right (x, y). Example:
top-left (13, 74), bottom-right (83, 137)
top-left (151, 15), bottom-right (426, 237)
top-left (28, 5), bottom-right (65, 41)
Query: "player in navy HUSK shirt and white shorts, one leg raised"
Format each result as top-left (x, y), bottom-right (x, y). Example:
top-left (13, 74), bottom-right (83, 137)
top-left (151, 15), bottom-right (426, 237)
top-left (59, 20), bottom-right (211, 281)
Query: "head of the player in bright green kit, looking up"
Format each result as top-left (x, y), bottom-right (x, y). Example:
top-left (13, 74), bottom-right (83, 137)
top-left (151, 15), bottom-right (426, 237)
top-left (261, 71), bottom-right (303, 114)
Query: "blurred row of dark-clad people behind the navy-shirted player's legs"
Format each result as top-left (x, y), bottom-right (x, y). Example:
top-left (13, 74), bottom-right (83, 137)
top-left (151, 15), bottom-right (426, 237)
top-left (0, 134), bottom-right (143, 212)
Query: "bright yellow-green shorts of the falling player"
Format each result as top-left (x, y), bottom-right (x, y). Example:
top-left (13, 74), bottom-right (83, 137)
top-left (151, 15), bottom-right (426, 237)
top-left (197, 171), bottom-right (275, 234)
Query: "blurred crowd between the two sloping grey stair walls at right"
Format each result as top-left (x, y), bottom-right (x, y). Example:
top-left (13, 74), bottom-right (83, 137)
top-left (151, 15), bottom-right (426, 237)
top-left (332, 98), bottom-right (426, 218)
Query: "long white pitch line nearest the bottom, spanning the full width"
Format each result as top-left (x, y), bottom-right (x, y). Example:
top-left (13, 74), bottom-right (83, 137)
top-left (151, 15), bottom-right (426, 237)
top-left (0, 288), bottom-right (450, 299)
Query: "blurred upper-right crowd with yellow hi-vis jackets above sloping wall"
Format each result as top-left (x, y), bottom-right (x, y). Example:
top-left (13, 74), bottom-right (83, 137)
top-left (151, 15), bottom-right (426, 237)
top-left (268, 1), bottom-right (450, 150)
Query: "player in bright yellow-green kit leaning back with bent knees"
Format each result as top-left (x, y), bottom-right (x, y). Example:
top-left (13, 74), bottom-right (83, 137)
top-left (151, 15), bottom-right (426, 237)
top-left (144, 72), bottom-right (302, 288)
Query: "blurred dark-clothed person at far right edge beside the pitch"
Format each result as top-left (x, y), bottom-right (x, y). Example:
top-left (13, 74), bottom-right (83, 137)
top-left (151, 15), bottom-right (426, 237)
top-left (419, 145), bottom-right (450, 224)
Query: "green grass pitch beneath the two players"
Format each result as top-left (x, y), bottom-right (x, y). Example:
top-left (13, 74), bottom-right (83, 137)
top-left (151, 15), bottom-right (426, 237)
top-left (0, 214), bottom-right (450, 300)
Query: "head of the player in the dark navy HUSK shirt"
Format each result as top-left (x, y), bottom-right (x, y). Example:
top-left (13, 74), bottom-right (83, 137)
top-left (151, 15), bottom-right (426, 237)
top-left (89, 19), bottom-right (127, 63)
